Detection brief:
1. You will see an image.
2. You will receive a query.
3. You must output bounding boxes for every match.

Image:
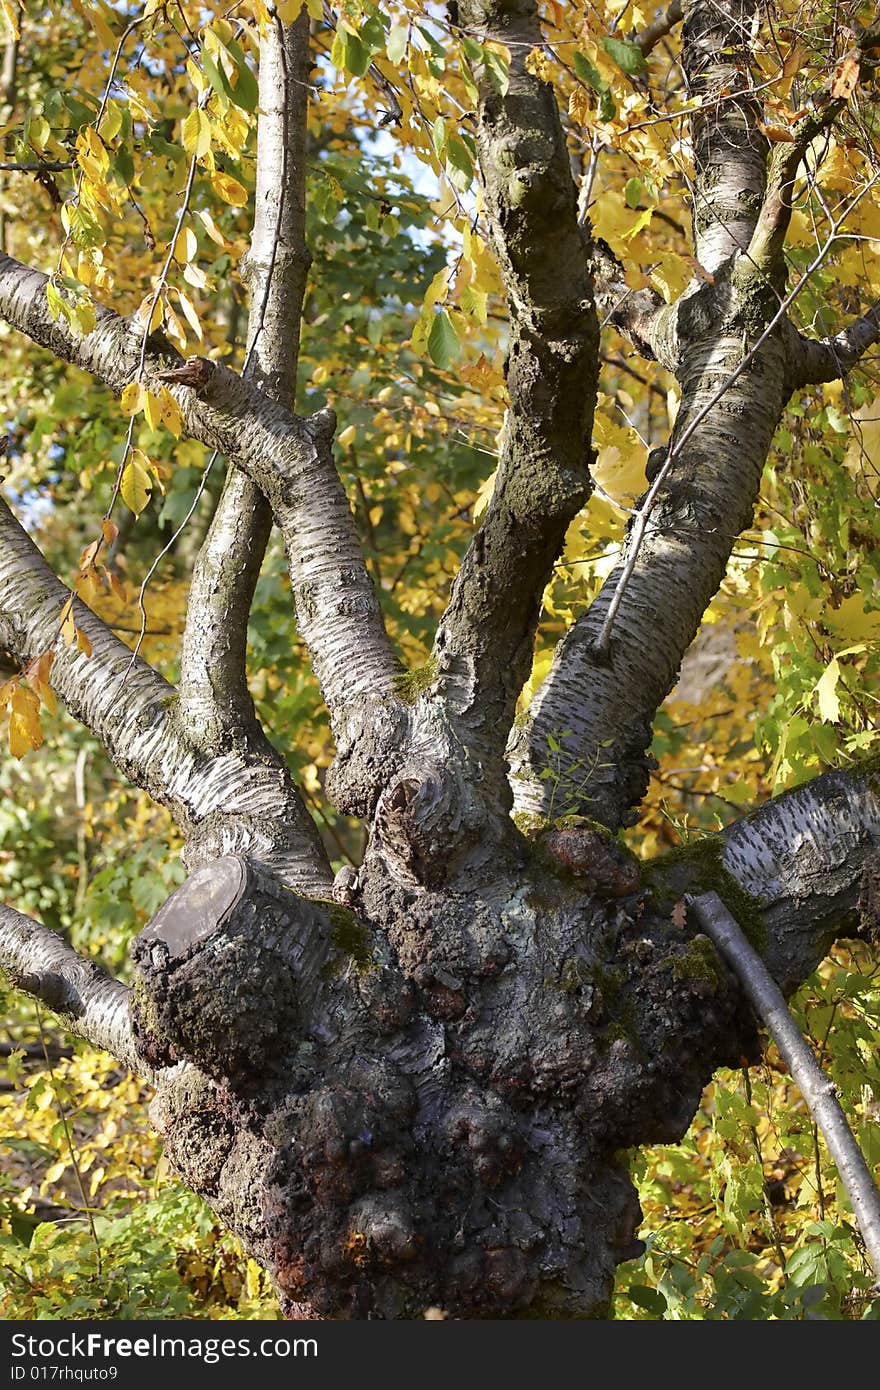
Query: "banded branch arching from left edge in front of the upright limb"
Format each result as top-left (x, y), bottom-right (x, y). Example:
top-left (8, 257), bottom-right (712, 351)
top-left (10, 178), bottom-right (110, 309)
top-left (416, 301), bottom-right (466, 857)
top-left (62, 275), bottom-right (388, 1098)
top-left (0, 254), bottom-right (398, 778)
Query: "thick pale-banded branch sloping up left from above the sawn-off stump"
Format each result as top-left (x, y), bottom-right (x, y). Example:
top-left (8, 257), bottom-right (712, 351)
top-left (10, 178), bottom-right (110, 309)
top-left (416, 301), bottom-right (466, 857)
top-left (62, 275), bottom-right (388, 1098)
top-left (0, 500), bottom-right (331, 897)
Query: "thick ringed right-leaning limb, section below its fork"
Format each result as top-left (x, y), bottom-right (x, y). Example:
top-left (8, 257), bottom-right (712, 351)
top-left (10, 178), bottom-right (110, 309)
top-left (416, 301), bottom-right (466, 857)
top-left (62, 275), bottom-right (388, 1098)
top-left (510, 296), bottom-right (787, 828)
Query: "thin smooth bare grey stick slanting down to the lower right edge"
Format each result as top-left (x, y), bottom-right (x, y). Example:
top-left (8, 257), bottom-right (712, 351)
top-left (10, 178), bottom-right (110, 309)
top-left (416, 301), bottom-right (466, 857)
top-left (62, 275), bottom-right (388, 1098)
top-left (688, 892), bottom-right (880, 1286)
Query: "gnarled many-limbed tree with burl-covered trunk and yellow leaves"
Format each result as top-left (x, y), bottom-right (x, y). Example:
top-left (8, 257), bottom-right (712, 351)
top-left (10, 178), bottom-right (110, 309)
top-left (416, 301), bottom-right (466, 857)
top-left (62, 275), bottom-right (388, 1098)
top-left (0, 0), bottom-right (880, 1318)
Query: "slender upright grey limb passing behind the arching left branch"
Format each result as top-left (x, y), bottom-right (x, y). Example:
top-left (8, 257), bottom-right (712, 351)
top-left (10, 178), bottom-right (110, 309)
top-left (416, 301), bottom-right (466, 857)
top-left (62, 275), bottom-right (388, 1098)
top-left (179, 11), bottom-right (309, 739)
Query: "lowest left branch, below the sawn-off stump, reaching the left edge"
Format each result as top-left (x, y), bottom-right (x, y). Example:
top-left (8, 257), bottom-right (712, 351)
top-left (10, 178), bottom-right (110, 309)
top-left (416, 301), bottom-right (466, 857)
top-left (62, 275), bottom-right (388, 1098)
top-left (0, 904), bottom-right (145, 1074)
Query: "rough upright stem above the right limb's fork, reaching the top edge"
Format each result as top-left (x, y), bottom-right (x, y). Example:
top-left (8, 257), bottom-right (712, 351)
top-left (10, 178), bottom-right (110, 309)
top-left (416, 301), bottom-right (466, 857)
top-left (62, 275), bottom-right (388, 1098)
top-left (681, 0), bottom-right (767, 272)
